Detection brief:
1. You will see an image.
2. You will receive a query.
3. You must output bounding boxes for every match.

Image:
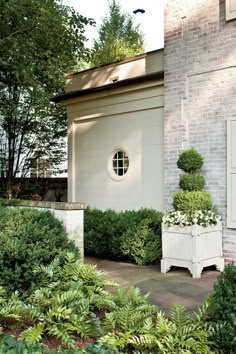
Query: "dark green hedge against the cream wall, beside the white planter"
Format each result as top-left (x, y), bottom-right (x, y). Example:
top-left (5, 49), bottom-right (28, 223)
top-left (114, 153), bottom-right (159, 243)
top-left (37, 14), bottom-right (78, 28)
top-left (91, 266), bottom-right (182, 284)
top-left (84, 208), bottom-right (162, 264)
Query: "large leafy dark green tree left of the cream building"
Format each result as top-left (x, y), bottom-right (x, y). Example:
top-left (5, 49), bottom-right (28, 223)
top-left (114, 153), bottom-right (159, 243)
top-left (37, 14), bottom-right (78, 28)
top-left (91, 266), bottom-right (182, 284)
top-left (0, 0), bottom-right (93, 197)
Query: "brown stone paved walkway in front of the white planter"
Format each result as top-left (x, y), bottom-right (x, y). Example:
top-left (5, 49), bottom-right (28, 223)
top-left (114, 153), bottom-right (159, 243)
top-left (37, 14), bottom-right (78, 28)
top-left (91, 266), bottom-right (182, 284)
top-left (85, 257), bottom-right (219, 311)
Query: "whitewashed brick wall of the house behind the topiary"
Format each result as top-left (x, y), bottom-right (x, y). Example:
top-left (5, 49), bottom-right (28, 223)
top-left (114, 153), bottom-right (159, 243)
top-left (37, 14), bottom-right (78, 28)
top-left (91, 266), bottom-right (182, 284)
top-left (164, 0), bottom-right (236, 262)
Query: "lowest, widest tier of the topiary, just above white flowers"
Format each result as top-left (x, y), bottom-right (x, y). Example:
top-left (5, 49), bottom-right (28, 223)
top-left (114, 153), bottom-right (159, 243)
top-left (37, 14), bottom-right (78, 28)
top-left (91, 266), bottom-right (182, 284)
top-left (173, 191), bottom-right (212, 212)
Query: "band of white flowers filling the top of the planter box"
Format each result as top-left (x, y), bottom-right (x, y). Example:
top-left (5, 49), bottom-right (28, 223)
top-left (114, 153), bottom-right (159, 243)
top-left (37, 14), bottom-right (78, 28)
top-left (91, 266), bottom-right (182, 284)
top-left (162, 210), bottom-right (221, 227)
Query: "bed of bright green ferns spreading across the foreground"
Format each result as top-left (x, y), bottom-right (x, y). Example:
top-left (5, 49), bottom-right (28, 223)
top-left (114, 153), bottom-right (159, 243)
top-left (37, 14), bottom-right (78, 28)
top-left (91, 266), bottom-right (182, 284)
top-left (0, 249), bottom-right (235, 354)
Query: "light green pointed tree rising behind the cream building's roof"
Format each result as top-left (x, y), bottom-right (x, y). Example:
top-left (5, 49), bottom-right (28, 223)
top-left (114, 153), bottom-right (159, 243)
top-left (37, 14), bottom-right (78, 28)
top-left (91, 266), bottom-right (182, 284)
top-left (91, 0), bottom-right (144, 66)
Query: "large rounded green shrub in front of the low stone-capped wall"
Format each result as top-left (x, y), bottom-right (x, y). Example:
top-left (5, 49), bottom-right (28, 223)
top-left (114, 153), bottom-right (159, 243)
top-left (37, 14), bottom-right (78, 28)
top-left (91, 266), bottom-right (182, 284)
top-left (0, 208), bottom-right (78, 294)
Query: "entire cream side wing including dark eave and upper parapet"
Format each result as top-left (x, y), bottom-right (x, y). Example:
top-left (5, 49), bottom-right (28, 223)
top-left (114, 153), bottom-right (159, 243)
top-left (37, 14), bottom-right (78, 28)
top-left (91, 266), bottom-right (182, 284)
top-left (61, 50), bottom-right (164, 210)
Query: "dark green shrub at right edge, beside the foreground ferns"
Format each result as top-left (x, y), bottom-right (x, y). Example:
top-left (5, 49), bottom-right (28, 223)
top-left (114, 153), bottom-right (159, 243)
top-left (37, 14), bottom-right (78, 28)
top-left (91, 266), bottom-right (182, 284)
top-left (207, 263), bottom-right (236, 354)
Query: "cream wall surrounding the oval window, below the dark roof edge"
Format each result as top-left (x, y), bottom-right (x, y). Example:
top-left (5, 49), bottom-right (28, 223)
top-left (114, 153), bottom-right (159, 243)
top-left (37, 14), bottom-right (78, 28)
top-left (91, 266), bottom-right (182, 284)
top-left (67, 80), bottom-right (164, 210)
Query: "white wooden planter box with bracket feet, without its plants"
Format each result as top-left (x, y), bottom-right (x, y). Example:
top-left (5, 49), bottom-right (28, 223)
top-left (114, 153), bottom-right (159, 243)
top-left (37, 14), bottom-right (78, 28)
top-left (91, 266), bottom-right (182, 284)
top-left (161, 223), bottom-right (224, 278)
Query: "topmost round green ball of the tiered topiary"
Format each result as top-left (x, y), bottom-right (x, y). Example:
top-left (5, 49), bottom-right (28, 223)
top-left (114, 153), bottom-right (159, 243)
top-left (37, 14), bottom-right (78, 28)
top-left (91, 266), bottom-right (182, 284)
top-left (177, 148), bottom-right (204, 173)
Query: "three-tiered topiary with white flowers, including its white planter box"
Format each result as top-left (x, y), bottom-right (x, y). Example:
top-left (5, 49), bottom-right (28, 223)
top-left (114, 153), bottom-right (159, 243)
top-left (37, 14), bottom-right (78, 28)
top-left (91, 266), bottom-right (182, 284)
top-left (161, 148), bottom-right (224, 278)
